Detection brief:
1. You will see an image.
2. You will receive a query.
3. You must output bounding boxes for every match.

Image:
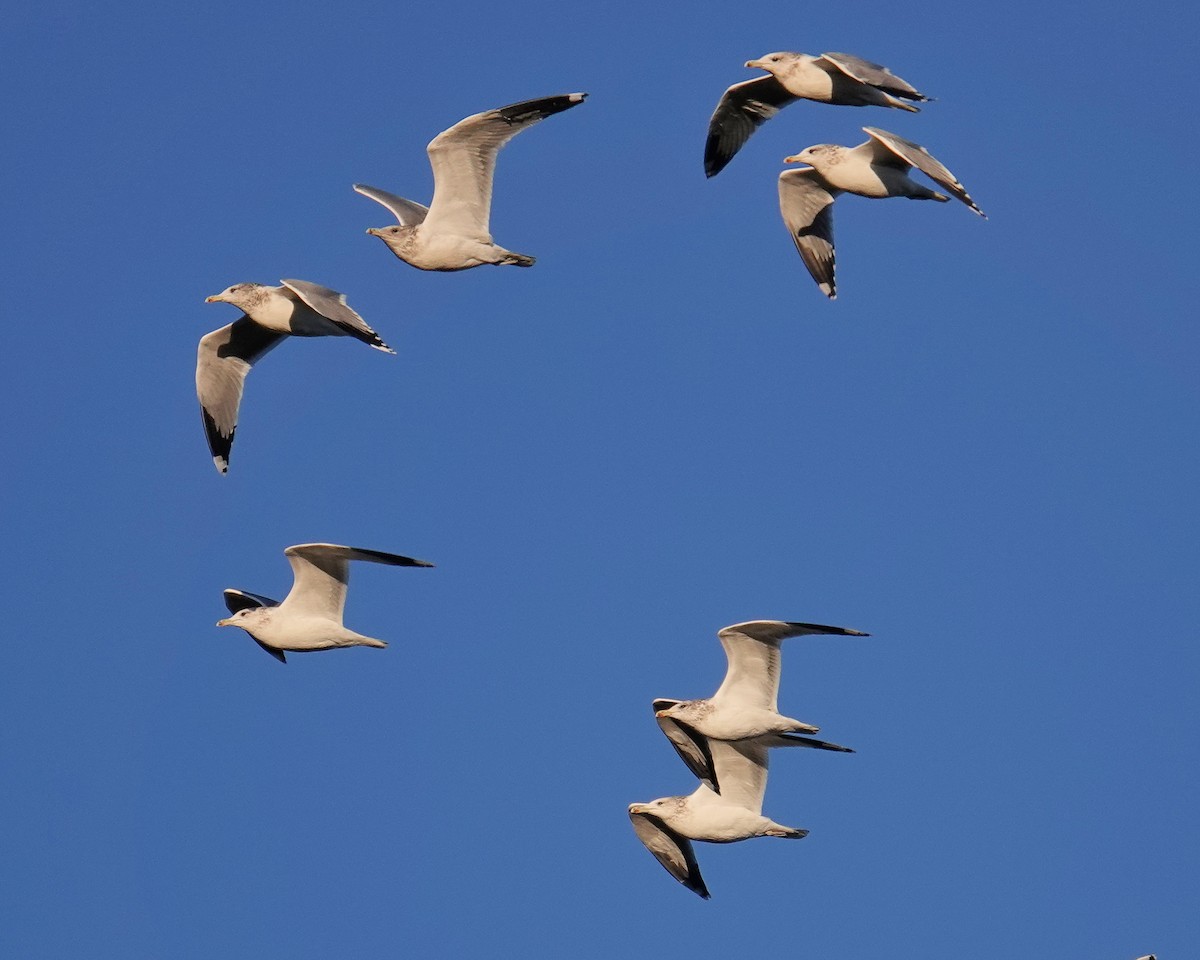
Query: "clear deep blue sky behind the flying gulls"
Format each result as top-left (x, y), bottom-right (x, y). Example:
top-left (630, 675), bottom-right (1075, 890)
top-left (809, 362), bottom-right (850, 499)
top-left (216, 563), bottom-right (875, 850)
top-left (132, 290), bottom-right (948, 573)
top-left (0, 0), bottom-right (1200, 960)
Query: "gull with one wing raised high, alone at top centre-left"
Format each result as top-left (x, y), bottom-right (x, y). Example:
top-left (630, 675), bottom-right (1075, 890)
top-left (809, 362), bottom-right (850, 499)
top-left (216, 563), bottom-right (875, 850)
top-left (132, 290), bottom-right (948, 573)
top-left (354, 94), bottom-right (587, 270)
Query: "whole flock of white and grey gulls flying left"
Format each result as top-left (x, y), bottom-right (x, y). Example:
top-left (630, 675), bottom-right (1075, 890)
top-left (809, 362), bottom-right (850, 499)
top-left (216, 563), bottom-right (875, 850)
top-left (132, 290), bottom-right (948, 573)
top-left (184, 53), bottom-right (1154, 936)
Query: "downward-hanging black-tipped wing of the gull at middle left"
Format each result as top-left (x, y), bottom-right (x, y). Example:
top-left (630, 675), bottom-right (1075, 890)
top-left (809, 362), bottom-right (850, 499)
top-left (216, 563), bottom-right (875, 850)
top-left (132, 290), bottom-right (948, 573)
top-left (196, 317), bottom-right (287, 473)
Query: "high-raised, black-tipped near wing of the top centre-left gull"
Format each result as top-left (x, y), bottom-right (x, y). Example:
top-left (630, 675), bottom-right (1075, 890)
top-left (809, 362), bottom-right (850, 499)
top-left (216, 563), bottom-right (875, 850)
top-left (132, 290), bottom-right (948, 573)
top-left (424, 94), bottom-right (587, 242)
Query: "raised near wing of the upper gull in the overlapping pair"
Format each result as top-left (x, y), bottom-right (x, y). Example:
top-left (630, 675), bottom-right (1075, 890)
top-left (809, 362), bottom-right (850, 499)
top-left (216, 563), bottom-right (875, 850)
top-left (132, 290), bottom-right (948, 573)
top-left (712, 620), bottom-right (870, 710)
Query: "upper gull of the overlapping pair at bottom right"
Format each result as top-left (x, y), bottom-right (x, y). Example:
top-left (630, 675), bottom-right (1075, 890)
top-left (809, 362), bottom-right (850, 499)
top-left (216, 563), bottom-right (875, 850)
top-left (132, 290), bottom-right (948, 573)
top-left (654, 620), bottom-right (870, 744)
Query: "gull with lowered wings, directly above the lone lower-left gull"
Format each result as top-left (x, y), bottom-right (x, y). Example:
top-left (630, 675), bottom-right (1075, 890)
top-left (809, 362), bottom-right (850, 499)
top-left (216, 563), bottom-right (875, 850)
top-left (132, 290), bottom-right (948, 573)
top-left (196, 280), bottom-right (395, 473)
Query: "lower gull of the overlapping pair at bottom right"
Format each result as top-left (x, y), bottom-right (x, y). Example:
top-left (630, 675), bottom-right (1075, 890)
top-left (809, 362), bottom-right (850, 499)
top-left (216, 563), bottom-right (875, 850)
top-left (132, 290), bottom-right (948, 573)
top-left (629, 740), bottom-right (809, 900)
